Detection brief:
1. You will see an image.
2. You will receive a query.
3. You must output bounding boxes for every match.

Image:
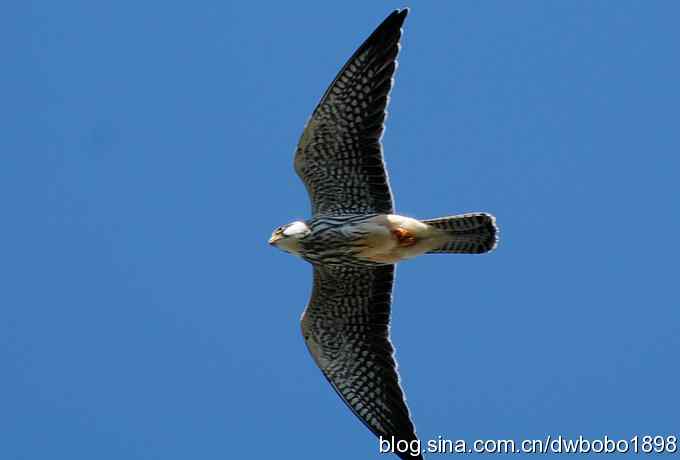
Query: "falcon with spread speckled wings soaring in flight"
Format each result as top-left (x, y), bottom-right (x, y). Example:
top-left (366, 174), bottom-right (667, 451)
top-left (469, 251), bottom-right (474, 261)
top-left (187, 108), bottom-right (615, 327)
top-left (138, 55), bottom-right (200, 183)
top-left (269, 9), bottom-right (498, 459)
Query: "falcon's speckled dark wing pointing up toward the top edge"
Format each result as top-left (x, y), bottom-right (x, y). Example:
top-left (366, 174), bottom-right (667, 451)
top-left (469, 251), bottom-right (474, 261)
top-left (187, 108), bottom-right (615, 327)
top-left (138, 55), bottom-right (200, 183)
top-left (295, 9), bottom-right (408, 214)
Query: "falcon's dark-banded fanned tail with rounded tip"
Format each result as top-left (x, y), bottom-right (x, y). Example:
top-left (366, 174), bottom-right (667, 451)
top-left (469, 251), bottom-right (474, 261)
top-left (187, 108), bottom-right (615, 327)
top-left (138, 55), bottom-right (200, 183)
top-left (423, 213), bottom-right (498, 254)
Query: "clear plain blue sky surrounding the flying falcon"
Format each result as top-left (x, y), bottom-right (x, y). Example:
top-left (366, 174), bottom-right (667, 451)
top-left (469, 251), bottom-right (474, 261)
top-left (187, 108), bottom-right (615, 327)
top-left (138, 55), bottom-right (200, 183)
top-left (6, 0), bottom-right (680, 460)
